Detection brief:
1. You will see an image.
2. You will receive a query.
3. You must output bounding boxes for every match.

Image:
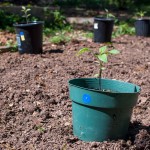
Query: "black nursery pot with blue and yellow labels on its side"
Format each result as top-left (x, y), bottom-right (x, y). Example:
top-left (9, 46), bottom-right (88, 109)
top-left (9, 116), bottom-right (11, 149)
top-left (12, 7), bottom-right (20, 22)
top-left (14, 21), bottom-right (44, 54)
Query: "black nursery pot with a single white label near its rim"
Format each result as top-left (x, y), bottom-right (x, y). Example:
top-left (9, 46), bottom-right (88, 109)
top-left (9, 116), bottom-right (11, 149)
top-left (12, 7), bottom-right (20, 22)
top-left (94, 17), bottom-right (114, 43)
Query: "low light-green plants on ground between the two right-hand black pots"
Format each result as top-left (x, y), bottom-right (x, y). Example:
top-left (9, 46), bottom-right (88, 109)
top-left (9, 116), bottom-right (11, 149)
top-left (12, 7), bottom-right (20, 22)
top-left (112, 22), bottom-right (135, 37)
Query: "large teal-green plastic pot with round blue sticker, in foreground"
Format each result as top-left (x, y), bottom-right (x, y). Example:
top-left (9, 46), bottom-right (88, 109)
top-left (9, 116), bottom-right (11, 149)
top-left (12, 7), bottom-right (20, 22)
top-left (69, 78), bottom-right (140, 141)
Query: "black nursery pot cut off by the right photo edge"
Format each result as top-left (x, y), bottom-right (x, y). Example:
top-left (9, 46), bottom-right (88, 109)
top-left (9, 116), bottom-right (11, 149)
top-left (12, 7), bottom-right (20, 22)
top-left (135, 19), bottom-right (150, 37)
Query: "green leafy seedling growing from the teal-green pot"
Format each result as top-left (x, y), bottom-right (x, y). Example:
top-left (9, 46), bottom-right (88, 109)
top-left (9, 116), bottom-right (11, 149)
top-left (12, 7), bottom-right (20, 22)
top-left (77, 45), bottom-right (119, 90)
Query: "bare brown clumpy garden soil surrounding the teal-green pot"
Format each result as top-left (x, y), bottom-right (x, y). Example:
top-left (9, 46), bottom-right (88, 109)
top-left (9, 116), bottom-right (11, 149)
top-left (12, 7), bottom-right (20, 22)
top-left (0, 35), bottom-right (150, 150)
